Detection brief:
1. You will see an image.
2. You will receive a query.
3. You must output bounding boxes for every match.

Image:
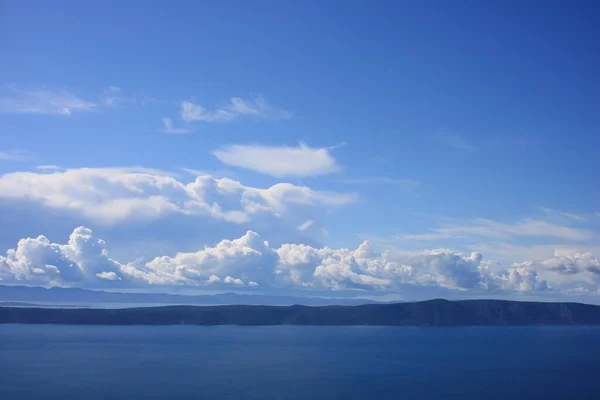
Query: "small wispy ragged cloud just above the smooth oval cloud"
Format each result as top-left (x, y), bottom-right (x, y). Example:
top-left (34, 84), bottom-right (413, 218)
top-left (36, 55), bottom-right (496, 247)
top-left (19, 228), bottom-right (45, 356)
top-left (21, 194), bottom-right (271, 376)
top-left (181, 96), bottom-right (291, 122)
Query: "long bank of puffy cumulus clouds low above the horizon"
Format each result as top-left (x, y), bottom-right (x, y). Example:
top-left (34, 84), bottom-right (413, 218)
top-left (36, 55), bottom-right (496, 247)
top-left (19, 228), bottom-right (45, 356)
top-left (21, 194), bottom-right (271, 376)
top-left (0, 227), bottom-right (600, 293)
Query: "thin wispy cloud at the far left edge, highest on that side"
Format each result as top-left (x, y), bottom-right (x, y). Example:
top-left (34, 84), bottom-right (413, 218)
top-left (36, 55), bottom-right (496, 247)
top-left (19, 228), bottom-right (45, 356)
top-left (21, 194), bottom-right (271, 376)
top-left (0, 85), bottom-right (98, 115)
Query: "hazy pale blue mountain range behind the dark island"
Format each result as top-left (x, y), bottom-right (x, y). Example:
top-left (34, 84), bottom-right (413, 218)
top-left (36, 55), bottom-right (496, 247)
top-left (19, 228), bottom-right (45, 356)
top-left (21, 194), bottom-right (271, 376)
top-left (0, 285), bottom-right (377, 306)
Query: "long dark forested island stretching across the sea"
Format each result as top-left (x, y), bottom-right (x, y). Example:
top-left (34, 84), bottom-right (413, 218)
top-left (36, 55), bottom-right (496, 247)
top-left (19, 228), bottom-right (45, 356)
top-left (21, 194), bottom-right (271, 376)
top-left (0, 299), bottom-right (600, 326)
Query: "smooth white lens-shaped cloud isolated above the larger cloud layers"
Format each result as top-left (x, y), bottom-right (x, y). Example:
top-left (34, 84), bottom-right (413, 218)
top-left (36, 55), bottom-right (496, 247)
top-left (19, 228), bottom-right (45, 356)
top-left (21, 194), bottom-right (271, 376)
top-left (213, 143), bottom-right (340, 178)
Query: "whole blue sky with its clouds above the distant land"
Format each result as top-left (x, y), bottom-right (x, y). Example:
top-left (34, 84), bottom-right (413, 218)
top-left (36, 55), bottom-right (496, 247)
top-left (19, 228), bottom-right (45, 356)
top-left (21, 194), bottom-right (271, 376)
top-left (0, 0), bottom-right (600, 303)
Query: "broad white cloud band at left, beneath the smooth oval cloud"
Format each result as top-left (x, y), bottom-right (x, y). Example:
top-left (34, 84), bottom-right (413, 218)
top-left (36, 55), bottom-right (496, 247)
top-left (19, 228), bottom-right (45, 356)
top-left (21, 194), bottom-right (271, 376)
top-left (0, 168), bottom-right (354, 225)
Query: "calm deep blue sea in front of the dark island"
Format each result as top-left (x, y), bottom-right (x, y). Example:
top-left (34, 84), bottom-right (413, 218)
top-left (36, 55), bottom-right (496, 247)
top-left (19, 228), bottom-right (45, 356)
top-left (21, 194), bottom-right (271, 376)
top-left (0, 325), bottom-right (600, 400)
